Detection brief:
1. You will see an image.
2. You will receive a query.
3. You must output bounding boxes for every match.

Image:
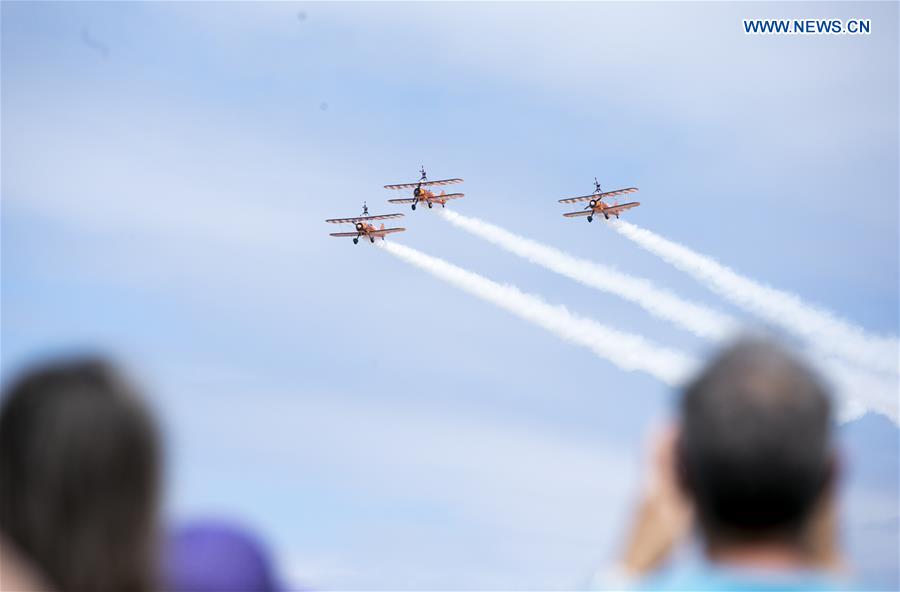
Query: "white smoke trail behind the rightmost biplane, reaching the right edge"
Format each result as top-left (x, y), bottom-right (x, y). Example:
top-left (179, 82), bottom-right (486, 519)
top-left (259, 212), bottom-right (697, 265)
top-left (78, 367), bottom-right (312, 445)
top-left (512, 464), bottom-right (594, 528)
top-left (611, 220), bottom-right (900, 376)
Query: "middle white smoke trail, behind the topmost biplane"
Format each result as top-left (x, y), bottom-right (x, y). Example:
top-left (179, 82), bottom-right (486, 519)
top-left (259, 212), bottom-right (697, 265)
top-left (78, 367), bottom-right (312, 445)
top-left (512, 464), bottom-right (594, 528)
top-left (440, 210), bottom-right (739, 341)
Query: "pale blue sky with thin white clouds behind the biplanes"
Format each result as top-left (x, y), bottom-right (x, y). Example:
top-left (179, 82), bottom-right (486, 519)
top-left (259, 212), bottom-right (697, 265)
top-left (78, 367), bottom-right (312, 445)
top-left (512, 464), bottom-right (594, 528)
top-left (0, 3), bottom-right (900, 589)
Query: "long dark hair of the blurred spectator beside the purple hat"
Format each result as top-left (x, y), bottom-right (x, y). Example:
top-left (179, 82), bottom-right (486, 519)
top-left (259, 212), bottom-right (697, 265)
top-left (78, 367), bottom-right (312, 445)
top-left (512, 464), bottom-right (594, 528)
top-left (0, 359), bottom-right (159, 592)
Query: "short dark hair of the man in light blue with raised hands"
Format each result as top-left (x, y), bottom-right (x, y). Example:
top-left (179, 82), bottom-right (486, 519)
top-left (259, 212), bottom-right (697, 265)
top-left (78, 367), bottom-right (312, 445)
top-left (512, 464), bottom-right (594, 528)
top-left (678, 339), bottom-right (832, 543)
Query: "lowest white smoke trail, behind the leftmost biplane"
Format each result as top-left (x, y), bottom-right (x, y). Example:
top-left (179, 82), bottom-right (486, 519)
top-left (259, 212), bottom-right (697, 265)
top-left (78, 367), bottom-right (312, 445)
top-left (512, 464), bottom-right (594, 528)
top-left (377, 241), bottom-right (698, 386)
